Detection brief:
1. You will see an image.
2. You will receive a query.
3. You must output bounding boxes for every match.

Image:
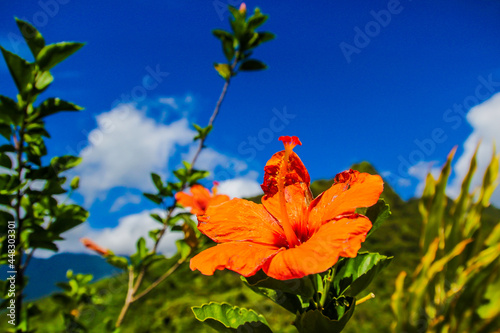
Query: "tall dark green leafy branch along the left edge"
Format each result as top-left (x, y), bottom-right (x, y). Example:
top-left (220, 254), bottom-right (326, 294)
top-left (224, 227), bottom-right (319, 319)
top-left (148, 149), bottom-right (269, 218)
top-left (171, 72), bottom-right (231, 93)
top-left (0, 19), bottom-right (88, 332)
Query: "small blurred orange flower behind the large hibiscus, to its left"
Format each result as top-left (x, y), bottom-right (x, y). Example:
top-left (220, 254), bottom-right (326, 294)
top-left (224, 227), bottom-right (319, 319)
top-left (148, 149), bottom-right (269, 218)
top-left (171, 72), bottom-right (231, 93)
top-left (175, 182), bottom-right (229, 215)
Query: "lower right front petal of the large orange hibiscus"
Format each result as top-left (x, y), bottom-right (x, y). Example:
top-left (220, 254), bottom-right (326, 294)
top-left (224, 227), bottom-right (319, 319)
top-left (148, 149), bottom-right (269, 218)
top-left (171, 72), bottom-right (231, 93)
top-left (262, 214), bottom-right (372, 280)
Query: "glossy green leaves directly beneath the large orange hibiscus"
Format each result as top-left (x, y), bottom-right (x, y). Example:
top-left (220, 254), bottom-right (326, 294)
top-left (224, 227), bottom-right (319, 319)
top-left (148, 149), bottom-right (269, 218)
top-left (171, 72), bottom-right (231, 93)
top-left (192, 200), bottom-right (392, 333)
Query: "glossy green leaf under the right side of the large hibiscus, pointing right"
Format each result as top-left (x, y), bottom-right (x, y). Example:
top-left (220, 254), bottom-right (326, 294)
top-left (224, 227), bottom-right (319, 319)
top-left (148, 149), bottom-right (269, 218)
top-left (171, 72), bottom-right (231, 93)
top-left (333, 253), bottom-right (393, 296)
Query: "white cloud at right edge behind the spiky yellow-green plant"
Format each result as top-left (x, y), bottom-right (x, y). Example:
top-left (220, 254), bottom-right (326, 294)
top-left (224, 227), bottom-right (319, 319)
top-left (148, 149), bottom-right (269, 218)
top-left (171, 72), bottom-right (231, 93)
top-left (449, 93), bottom-right (500, 207)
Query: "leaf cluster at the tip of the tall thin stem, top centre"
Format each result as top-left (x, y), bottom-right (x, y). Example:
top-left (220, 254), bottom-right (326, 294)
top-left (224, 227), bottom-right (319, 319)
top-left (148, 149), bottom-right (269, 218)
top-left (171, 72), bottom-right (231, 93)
top-left (212, 6), bottom-right (275, 81)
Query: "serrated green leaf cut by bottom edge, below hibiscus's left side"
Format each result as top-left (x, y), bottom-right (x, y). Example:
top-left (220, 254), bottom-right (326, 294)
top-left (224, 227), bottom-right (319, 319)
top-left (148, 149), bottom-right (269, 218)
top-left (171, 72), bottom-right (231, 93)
top-left (191, 302), bottom-right (272, 333)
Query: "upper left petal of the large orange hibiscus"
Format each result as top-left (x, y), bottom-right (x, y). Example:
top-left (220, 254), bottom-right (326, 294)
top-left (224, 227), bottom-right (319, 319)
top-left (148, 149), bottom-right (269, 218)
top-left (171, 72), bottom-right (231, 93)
top-left (198, 198), bottom-right (286, 247)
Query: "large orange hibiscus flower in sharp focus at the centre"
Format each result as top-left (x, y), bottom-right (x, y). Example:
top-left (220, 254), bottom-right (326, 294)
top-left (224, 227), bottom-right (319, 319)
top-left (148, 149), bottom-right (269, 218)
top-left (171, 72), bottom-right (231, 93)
top-left (190, 136), bottom-right (383, 280)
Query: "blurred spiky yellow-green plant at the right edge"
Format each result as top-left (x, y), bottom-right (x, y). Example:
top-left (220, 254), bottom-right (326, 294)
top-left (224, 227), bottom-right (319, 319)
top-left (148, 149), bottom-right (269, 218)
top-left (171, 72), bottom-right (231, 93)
top-left (391, 149), bottom-right (500, 333)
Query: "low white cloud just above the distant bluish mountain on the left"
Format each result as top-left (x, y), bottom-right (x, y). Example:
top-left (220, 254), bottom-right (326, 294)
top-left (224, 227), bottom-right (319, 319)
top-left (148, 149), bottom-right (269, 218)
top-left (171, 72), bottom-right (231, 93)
top-left (35, 209), bottom-right (184, 258)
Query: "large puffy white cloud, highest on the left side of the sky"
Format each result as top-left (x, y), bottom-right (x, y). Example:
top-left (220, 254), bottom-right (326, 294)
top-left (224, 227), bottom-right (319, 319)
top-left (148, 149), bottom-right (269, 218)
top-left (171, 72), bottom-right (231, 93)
top-left (75, 104), bottom-right (194, 204)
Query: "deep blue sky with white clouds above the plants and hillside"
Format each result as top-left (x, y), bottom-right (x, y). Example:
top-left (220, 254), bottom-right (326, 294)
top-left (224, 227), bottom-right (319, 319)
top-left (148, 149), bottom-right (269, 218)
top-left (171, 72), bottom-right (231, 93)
top-left (0, 0), bottom-right (500, 252)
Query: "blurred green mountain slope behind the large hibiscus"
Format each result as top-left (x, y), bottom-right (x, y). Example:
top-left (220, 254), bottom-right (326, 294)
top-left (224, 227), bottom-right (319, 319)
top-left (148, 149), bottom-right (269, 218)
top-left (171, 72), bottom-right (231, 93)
top-left (0, 162), bottom-right (500, 333)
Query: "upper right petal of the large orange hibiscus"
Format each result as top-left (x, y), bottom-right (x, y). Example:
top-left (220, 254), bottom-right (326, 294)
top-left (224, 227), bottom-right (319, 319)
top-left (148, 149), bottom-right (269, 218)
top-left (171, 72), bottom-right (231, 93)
top-left (309, 170), bottom-right (384, 232)
